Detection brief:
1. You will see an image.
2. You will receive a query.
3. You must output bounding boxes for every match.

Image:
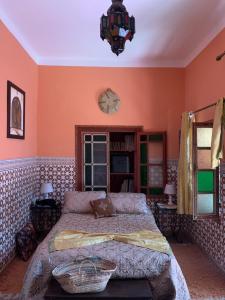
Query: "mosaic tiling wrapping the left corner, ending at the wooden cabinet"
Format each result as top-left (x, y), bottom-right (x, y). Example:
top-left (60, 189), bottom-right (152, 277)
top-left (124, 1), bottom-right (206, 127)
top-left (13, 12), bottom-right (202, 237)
top-left (0, 157), bottom-right (76, 271)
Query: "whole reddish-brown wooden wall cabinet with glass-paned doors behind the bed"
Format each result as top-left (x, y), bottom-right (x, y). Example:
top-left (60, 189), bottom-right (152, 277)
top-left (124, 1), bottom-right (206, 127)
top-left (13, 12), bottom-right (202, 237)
top-left (76, 126), bottom-right (166, 197)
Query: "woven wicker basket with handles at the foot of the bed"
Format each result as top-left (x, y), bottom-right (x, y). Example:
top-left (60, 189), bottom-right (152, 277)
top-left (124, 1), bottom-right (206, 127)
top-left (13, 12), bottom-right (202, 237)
top-left (52, 257), bottom-right (116, 294)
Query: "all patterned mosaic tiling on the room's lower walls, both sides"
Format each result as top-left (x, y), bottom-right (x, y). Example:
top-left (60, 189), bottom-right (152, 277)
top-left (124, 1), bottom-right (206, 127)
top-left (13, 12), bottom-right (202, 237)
top-left (0, 157), bottom-right (225, 271)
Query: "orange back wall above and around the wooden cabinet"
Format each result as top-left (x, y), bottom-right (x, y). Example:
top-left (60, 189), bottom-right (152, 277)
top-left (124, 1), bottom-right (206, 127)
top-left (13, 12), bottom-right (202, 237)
top-left (38, 66), bottom-right (185, 158)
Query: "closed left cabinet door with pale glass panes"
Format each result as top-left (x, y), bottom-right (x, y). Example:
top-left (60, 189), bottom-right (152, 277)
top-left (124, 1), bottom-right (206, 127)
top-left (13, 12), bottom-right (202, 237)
top-left (82, 132), bottom-right (109, 191)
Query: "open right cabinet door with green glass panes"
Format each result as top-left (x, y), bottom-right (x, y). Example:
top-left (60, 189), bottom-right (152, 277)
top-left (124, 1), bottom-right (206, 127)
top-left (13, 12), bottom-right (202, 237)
top-left (137, 132), bottom-right (167, 200)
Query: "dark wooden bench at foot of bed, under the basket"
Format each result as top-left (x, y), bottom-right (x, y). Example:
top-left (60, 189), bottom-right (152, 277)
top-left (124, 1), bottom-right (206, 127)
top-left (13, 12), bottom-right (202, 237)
top-left (44, 278), bottom-right (153, 300)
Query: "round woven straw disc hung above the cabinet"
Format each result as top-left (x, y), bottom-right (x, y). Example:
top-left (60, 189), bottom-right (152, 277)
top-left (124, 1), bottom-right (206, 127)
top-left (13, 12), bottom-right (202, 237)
top-left (98, 89), bottom-right (120, 114)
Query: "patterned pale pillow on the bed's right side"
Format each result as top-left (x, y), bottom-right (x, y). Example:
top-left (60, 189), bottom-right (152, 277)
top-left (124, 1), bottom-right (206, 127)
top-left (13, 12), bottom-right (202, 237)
top-left (108, 193), bottom-right (150, 214)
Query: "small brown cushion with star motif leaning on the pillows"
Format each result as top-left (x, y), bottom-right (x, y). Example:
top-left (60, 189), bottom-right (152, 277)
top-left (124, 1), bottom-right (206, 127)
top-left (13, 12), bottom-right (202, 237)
top-left (90, 199), bottom-right (116, 218)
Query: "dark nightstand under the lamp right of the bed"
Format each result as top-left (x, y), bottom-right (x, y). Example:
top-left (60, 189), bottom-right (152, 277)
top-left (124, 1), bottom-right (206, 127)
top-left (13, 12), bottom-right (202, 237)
top-left (155, 202), bottom-right (180, 238)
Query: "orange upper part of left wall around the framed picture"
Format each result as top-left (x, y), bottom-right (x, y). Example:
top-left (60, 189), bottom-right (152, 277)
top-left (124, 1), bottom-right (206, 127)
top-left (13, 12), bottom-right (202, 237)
top-left (0, 21), bottom-right (38, 159)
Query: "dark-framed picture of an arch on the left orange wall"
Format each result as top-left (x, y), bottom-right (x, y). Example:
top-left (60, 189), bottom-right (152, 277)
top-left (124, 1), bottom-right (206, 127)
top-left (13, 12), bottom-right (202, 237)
top-left (7, 81), bottom-right (25, 139)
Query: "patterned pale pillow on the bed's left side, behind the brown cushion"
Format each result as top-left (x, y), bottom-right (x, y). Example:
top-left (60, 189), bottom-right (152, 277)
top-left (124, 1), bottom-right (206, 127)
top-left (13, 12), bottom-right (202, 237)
top-left (63, 191), bottom-right (106, 213)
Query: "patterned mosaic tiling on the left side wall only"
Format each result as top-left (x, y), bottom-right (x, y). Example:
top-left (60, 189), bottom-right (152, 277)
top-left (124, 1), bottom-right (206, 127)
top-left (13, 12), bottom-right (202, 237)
top-left (0, 158), bottom-right (38, 271)
